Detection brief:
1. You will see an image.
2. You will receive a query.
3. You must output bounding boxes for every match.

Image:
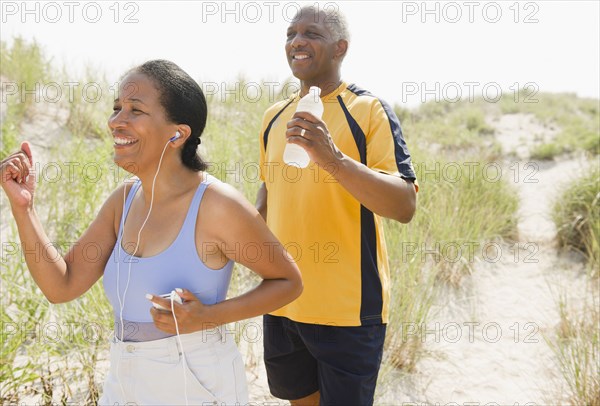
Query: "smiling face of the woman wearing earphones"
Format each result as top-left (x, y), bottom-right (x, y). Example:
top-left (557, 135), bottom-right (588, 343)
top-left (108, 73), bottom-right (177, 174)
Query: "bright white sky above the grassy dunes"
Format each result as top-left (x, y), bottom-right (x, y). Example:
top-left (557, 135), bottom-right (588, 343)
top-left (0, 1), bottom-right (600, 106)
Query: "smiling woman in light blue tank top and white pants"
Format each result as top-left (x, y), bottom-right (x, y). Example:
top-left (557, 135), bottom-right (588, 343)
top-left (0, 60), bottom-right (302, 405)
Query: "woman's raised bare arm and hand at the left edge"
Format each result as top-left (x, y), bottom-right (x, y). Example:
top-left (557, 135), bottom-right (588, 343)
top-left (0, 142), bottom-right (122, 303)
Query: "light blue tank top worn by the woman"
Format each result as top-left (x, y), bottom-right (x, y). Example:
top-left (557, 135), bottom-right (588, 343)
top-left (103, 174), bottom-right (234, 341)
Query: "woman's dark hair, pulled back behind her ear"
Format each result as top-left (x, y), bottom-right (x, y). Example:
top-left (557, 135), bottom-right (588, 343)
top-left (128, 59), bottom-right (207, 171)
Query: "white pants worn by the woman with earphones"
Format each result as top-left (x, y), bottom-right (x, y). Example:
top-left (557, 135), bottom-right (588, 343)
top-left (98, 328), bottom-right (248, 406)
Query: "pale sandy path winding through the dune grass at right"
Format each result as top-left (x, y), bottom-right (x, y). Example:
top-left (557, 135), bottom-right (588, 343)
top-left (382, 114), bottom-right (585, 405)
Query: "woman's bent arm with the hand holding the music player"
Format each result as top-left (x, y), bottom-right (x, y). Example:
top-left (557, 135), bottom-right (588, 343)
top-left (151, 184), bottom-right (302, 334)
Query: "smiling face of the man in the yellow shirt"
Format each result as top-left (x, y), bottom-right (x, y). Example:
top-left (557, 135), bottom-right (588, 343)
top-left (285, 10), bottom-right (341, 83)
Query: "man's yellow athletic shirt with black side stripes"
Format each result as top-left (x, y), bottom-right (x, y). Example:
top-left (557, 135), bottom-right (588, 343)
top-left (260, 83), bottom-right (415, 326)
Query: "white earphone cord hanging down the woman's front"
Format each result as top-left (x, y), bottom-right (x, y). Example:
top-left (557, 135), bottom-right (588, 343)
top-left (116, 137), bottom-right (189, 405)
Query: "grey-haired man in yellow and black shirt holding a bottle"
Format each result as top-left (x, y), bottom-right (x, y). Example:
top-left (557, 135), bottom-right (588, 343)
top-left (257, 6), bottom-right (417, 405)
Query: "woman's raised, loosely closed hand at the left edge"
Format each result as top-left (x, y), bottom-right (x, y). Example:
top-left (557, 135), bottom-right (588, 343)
top-left (0, 142), bottom-right (35, 209)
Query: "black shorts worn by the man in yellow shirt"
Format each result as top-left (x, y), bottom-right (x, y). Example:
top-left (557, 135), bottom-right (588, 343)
top-left (263, 314), bottom-right (386, 406)
